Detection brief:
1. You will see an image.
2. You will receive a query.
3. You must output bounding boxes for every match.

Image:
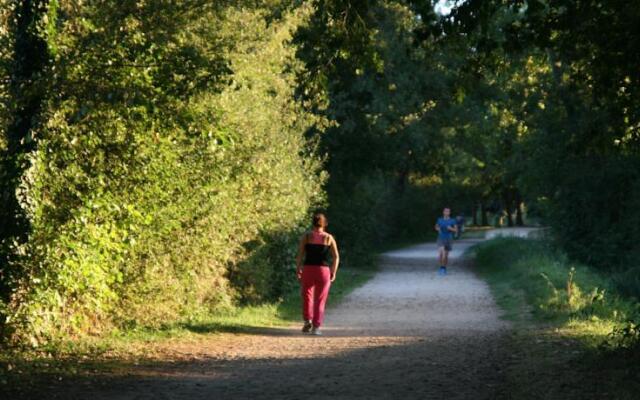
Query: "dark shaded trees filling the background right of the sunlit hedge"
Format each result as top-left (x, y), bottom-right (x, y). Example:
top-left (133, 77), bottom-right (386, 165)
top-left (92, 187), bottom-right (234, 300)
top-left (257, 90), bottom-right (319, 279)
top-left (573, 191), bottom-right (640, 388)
top-left (298, 0), bottom-right (640, 288)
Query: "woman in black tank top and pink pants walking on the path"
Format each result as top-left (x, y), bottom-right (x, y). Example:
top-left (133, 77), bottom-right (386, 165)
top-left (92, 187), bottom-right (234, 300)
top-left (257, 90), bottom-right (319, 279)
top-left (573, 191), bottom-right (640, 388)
top-left (296, 213), bottom-right (340, 335)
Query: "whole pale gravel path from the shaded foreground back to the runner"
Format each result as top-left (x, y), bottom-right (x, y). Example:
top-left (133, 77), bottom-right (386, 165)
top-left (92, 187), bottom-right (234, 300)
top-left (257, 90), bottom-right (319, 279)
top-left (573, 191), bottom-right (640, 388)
top-left (26, 240), bottom-right (508, 400)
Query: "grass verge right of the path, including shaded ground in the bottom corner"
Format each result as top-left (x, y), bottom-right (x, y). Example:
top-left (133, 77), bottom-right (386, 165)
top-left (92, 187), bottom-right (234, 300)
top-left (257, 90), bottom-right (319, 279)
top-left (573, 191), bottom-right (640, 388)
top-left (471, 238), bottom-right (640, 400)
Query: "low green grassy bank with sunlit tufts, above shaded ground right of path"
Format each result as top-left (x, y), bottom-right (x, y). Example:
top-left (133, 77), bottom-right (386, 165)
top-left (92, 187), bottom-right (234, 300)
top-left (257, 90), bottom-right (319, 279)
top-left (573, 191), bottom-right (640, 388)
top-left (474, 238), bottom-right (638, 326)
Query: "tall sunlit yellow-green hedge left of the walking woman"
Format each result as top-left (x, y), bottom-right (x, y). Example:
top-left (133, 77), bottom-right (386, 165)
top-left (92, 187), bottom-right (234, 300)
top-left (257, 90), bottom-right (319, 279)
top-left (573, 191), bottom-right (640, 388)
top-left (2, 1), bottom-right (323, 344)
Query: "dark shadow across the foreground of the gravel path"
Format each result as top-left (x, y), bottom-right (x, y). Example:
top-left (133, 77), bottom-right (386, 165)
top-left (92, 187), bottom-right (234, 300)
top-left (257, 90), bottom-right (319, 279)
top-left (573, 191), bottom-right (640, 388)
top-left (5, 336), bottom-right (503, 400)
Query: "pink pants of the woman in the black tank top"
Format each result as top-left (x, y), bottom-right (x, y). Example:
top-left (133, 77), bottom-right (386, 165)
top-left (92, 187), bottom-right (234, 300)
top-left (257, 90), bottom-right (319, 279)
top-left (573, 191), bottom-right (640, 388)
top-left (302, 265), bottom-right (331, 327)
